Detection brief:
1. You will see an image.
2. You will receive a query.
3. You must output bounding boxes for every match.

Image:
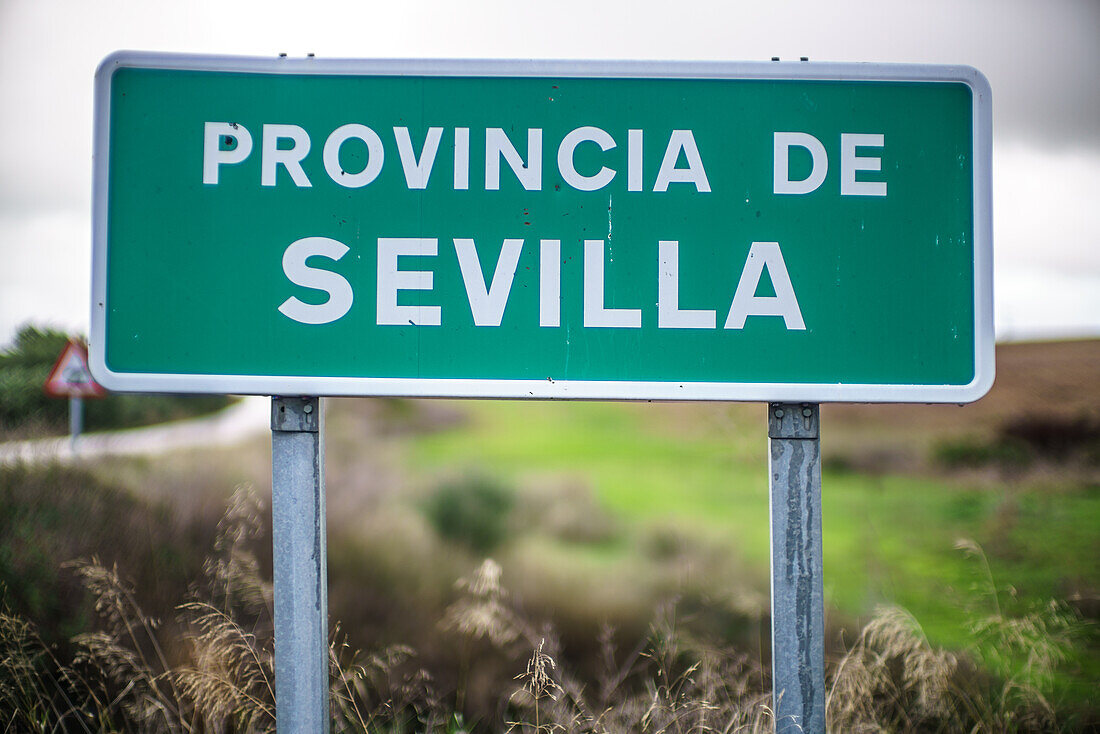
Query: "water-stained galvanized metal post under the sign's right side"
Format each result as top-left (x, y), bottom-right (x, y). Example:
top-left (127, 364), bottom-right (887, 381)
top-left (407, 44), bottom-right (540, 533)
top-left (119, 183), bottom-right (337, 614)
top-left (768, 403), bottom-right (825, 734)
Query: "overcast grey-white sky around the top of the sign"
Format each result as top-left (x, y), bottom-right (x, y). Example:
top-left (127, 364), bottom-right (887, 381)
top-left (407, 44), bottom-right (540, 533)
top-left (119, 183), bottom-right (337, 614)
top-left (0, 0), bottom-right (1100, 344)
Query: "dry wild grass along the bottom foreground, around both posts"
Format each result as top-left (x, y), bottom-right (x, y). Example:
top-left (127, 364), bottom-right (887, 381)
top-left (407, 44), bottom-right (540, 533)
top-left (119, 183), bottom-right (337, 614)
top-left (0, 489), bottom-right (1096, 734)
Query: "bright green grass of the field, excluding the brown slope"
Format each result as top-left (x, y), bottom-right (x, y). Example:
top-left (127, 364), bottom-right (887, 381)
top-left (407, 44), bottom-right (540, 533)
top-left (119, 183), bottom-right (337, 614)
top-left (416, 403), bottom-right (1100, 713)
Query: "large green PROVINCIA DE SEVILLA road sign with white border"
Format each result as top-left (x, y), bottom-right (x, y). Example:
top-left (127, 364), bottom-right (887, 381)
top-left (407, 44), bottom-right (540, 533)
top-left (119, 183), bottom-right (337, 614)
top-left (91, 53), bottom-right (993, 403)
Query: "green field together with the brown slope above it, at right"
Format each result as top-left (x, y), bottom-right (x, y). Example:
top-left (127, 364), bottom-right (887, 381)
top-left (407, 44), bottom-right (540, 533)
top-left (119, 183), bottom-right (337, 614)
top-left (402, 342), bottom-right (1100, 698)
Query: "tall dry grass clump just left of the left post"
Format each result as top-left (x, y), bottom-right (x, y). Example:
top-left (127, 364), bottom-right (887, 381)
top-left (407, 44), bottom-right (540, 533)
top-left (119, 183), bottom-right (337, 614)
top-left (63, 489), bottom-right (275, 732)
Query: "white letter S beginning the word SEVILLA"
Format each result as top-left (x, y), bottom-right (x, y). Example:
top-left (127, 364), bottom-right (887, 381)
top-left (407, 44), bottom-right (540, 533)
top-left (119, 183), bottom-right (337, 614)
top-left (278, 237), bottom-right (354, 324)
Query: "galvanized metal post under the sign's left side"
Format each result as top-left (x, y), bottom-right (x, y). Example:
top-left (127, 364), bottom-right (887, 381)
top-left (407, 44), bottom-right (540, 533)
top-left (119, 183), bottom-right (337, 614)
top-left (272, 397), bottom-right (329, 734)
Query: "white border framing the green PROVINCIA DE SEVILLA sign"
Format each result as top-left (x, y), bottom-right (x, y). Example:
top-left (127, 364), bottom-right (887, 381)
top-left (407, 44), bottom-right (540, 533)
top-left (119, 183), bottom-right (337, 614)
top-left (89, 51), bottom-right (994, 403)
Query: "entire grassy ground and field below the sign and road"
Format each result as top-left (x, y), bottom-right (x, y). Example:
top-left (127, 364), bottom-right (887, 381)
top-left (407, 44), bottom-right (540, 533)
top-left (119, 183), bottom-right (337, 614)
top-left (0, 343), bottom-right (1100, 734)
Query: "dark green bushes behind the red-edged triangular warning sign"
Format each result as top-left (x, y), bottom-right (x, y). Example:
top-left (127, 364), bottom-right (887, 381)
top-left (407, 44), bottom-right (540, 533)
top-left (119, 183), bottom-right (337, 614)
top-left (0, 326), bottom-right (230, 440)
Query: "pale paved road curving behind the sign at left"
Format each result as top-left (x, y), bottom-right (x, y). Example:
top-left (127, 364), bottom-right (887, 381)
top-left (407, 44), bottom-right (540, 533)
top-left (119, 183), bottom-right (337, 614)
top-left (0, 396), bottom-right (271, 464)
